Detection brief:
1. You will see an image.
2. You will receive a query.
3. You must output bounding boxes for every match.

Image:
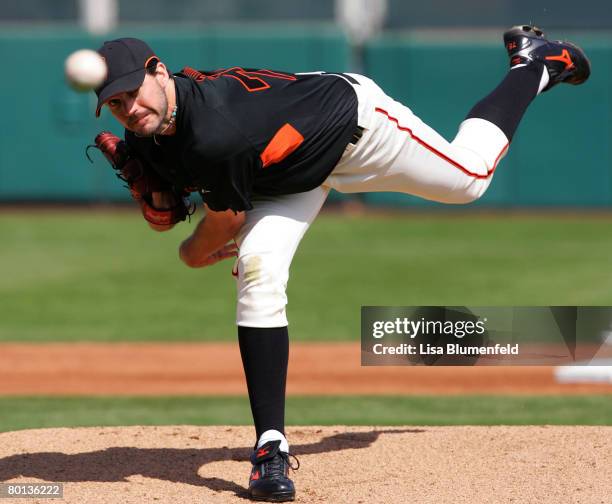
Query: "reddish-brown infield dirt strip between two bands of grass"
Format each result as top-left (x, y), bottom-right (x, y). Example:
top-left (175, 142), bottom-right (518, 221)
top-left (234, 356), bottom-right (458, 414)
top-left (0, 343), bottom-right (612, 397)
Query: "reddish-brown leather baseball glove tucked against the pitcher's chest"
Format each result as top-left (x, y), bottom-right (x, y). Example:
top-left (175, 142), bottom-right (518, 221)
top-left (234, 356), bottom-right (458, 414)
top-left (87, 131), bottom-right (193, 227)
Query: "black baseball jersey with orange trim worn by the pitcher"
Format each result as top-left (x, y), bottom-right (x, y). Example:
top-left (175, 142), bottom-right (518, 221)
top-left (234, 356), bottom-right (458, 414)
top-left (126, 68), bottom-right (357, 211)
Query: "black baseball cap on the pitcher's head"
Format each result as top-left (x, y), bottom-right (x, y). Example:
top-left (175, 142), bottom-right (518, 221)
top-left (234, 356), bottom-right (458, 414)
top-left (96, 38), bottom-right (159, 117)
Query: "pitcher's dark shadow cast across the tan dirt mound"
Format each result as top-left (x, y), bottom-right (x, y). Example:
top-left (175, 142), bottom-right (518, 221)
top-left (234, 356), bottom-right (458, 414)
top-left (0, 429), bottom-right (425, 497)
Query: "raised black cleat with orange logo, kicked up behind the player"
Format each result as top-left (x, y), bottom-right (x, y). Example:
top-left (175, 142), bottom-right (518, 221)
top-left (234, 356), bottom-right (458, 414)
top-left (504, 25), bottom-right (591, 91)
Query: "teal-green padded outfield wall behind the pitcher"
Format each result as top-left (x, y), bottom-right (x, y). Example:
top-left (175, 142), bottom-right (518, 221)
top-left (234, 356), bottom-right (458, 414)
top-left (0, 25), bottom-right (612, 207)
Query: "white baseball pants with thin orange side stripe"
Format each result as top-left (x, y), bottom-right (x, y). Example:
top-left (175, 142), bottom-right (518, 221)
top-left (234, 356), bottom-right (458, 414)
top-left (234, 74), bottom-right (508, 327)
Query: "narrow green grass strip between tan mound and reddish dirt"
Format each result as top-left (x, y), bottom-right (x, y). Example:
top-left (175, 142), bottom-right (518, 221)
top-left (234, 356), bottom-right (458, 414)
top-left (0, 395), bottom-right (612, 431)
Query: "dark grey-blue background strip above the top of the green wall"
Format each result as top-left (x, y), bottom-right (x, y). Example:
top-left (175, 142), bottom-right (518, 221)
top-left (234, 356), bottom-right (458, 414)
top-left (0, 0), bottom-right (612, 30)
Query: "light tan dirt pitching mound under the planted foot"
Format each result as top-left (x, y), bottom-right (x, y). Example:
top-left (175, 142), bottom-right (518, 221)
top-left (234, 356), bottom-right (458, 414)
top-left (0, 426), bottom-right (612, 504)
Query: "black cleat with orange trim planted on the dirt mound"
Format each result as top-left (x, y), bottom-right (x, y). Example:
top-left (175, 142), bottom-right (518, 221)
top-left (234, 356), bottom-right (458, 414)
top-left (249, 441), bottom-right (300, 502)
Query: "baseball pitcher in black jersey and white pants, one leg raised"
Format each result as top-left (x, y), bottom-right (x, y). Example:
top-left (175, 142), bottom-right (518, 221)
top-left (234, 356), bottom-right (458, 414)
top-left (89, 26), bottom-right (590, 501)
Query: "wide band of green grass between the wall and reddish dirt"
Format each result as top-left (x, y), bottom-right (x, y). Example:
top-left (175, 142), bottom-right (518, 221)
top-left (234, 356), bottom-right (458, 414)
top-left (0, 209), bottom-right (612, 341)
